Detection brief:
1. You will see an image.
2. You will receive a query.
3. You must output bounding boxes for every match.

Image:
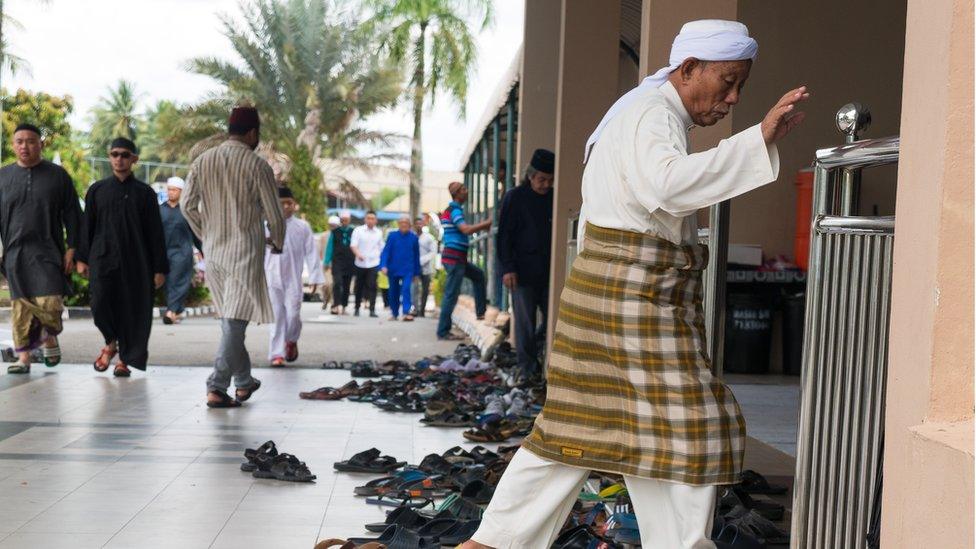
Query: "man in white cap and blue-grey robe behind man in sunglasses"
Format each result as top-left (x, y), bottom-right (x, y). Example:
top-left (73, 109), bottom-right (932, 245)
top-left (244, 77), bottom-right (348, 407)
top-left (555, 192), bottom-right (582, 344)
top-left (159, 177), bottom-right (203, 324)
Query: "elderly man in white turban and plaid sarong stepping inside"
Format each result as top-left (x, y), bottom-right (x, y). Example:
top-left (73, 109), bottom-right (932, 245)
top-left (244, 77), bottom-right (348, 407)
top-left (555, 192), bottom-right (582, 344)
top-left (462, 21), bottom-right (809, 549)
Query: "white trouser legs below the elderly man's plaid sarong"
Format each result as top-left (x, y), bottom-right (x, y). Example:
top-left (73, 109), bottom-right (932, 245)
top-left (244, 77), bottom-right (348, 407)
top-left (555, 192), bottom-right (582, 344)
top-left (471, 449), bottom-right (715, 549)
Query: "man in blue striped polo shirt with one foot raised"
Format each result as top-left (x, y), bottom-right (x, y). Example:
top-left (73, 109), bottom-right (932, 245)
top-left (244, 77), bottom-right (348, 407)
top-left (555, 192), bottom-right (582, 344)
top-left (437, 181), bottom-right (491, 339)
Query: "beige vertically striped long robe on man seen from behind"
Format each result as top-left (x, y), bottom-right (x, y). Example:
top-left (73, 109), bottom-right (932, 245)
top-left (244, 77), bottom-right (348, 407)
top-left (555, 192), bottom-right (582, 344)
top-left (180, 140), bottom-right (285, 324)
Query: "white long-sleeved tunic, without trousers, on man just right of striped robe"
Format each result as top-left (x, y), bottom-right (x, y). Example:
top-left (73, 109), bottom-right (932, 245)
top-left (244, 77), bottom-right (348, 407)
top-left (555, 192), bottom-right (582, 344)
top-left (264, 216), bottom-right (325, 294)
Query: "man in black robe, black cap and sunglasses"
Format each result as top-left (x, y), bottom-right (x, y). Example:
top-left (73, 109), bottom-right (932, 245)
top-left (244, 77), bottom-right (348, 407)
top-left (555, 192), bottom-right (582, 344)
top-left (77, 137), bottom-right (169, 377)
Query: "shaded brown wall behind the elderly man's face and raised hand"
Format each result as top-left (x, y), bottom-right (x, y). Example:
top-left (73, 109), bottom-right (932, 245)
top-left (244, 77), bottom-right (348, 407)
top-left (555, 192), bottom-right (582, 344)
top-left (730, 0), bottom-right (905, 258)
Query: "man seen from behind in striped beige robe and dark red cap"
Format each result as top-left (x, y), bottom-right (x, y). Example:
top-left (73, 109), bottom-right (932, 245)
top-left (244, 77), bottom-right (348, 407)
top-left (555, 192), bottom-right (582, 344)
top-left (180, 107), bottom-right (285, 408)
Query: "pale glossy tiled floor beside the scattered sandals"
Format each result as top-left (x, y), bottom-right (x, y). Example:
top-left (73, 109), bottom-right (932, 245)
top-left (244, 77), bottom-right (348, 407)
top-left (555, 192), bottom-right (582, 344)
top-left (0, 365), bottom-right (795, 549)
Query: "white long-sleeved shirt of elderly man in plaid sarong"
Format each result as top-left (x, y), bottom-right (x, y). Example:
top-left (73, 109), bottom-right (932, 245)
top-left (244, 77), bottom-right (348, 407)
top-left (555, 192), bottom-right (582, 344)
top-left (578, 82), bottom-right (779, 246)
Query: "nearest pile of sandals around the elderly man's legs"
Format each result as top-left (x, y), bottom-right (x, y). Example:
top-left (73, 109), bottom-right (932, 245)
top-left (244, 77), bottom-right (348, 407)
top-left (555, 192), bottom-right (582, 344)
top-left (316, 445), bottom-right (789, 549)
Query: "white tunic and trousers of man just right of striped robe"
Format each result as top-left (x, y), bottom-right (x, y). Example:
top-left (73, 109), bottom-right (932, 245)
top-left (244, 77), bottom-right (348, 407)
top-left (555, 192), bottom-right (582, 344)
top-left (264, 216), bottom-right (325, 360)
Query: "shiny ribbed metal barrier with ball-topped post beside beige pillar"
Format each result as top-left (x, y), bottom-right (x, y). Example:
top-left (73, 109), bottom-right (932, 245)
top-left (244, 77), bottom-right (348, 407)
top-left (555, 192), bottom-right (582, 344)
top-left (792, 104), bottom-right (899, 549)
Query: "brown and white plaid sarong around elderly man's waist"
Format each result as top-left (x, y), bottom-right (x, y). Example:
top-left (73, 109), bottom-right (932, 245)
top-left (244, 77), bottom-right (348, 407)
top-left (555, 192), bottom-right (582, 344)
top-left (523, 225), bottom-right (745, 485)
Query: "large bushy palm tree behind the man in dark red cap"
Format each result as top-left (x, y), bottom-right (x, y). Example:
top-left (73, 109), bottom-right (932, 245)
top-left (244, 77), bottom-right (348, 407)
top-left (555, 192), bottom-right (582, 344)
top-left (187, 0), bottom-right (402, 229)
